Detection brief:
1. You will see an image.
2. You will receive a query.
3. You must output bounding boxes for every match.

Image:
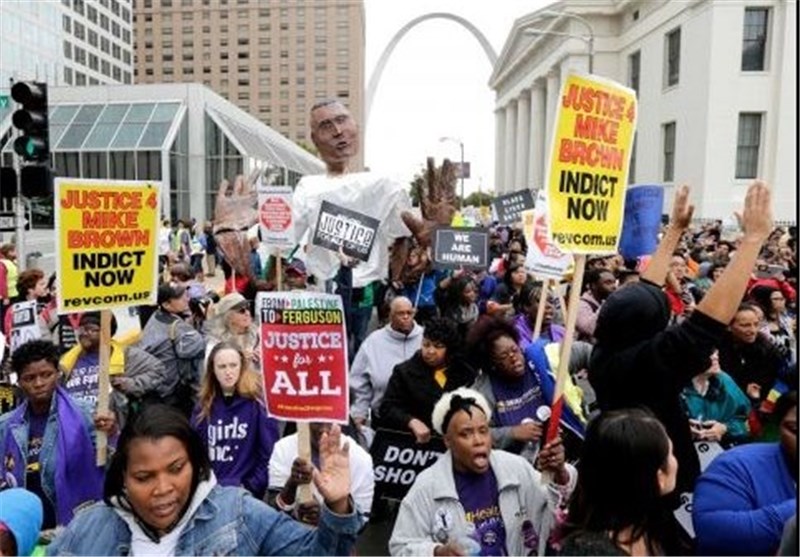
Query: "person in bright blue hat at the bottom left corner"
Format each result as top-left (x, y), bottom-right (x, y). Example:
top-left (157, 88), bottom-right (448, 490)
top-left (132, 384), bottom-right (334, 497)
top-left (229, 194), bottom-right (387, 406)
top-left (0, 487), bottom-right (42, 555)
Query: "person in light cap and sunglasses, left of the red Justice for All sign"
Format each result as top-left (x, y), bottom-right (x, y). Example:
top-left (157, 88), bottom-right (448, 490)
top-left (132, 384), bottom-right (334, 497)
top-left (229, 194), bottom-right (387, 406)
top-left (205, 292), bottom-right (261, 371)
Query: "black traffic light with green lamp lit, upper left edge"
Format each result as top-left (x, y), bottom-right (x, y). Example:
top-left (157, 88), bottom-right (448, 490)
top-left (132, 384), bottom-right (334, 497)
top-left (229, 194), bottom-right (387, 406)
top-left (11, 81), bottom-right (50, 162)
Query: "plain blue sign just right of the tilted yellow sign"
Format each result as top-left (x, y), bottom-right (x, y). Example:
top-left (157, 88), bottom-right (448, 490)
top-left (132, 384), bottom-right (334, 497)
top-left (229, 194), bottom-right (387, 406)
top-left (619, 185), bottom-right (664, 259)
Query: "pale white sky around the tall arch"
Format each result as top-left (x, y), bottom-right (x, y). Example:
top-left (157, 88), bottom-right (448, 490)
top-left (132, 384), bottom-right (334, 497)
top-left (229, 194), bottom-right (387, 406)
top-left (364, 0), bottom-right (553, 195)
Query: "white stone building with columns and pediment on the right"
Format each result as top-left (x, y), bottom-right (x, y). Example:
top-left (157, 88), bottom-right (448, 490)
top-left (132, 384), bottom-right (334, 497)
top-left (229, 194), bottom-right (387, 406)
top-left (489, 0), bottom-right (797, 222)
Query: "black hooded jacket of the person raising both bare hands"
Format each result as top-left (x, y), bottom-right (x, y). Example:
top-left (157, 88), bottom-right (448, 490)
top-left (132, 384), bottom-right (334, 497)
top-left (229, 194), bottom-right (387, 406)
top-left (589, 282), bottom-right (725, 490)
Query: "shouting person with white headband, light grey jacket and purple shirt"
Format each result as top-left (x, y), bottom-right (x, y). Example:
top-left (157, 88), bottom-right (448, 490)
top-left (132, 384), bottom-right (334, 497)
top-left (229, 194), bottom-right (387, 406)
top-left (389, 387), bottom-right (577, 555)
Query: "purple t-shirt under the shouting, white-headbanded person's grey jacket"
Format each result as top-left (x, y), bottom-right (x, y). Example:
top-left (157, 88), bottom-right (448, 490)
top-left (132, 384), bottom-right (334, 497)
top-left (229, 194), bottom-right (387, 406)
top-left (453, 469), bottom-right (508, 555)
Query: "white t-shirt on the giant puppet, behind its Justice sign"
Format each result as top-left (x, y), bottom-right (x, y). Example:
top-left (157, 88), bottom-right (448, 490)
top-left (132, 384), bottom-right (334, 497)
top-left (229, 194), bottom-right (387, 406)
top-left (292, 172), bottom-right (411, 288)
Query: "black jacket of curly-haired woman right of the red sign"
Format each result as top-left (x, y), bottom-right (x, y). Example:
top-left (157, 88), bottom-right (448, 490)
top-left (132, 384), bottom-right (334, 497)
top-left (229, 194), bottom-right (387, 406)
top-left (375, 350), bottom-right (476, 431)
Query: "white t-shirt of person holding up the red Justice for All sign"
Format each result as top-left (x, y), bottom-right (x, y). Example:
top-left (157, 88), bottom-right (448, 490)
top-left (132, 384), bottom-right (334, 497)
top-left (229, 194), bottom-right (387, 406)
top-left (269, 433), bottom-right (375, 515)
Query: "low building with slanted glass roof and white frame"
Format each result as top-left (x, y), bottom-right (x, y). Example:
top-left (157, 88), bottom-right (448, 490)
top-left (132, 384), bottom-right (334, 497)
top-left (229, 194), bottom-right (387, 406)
top-left (0, 84), bottom-right (324, 221)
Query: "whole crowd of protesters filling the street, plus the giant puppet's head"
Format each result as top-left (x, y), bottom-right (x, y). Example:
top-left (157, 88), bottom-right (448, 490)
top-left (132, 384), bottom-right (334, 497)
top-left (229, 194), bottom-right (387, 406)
top-left (0, 96), bottom-right (798, 555)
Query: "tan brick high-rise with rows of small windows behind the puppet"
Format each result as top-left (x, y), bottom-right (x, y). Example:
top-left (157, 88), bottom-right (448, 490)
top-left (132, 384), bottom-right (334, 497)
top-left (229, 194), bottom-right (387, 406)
top-left (134, 0), bottom-right (365, 166)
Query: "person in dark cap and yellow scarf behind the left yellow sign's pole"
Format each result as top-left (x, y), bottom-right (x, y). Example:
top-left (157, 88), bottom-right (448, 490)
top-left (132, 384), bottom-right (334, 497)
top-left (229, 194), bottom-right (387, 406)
top-left (59, 311), bottom-right (168, 428)
